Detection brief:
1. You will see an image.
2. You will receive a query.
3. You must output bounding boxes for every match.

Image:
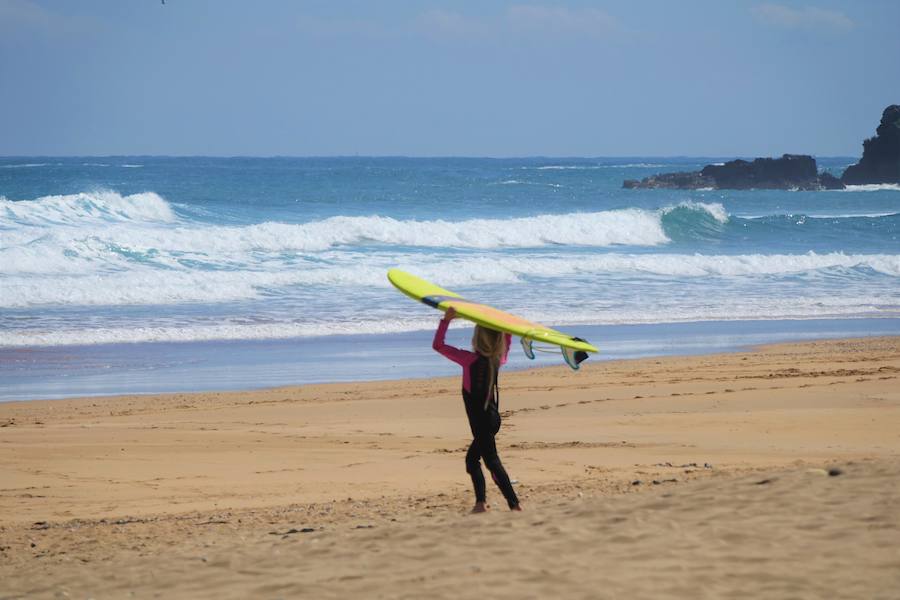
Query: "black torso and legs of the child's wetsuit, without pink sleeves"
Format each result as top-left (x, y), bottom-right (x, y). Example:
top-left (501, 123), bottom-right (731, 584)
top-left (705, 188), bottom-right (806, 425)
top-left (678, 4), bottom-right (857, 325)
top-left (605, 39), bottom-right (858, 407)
top-left (463, 355), bottom-right (519, 508)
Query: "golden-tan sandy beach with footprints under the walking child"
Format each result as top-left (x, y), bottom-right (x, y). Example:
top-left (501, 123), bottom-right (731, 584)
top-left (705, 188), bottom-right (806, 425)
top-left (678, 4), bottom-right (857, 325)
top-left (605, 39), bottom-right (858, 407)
top-left (0, 338), bottom-right (900, 598)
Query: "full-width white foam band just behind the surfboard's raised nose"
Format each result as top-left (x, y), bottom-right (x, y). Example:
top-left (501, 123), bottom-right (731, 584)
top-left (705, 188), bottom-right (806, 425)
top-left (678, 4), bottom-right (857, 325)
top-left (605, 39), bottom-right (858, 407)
top-left (0, 253), bottom-right (900, 308)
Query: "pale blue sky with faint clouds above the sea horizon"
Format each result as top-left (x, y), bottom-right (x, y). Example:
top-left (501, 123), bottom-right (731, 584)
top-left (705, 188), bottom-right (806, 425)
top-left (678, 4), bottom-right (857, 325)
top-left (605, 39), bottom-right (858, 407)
top-left (0, 0), bottom-right (900, 157)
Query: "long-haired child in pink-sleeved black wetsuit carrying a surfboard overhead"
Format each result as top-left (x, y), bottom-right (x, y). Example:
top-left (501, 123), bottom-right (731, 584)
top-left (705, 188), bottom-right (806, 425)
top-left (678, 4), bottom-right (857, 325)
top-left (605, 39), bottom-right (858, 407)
top-left (432, 308), bottom-right (522, 513)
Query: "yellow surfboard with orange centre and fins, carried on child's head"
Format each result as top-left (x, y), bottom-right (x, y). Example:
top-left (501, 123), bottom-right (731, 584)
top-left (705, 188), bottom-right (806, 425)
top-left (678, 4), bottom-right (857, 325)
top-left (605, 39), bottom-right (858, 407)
top-left (388, 269), bottom-right (599, 369)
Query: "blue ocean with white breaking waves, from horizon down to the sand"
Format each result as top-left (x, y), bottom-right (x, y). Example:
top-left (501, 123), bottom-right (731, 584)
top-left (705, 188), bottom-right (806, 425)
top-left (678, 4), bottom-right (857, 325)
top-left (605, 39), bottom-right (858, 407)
top-left (0, 156), bottom-right (900, 400)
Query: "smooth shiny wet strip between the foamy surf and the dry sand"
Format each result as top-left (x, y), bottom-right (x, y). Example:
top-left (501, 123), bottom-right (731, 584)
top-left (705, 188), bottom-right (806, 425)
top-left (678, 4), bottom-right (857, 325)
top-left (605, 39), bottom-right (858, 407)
top-left (0, 317), bottom-right (900, 403)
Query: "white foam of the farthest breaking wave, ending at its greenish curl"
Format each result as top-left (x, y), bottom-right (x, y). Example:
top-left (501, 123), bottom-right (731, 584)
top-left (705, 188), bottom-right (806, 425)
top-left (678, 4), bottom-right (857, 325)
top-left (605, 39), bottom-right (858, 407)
top-left (0, 191), bottom-right (728, 260)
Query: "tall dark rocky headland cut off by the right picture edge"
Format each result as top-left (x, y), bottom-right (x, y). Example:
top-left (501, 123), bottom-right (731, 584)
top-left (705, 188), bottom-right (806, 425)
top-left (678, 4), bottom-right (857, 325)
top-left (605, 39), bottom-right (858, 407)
top-left (841, 104), bottom-right (900, 185)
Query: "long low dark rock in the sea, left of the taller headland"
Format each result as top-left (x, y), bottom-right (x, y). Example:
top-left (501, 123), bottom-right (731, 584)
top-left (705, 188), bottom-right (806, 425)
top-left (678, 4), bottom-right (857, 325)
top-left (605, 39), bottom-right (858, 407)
top-left (622, 154), bottom-right (844, 190)
